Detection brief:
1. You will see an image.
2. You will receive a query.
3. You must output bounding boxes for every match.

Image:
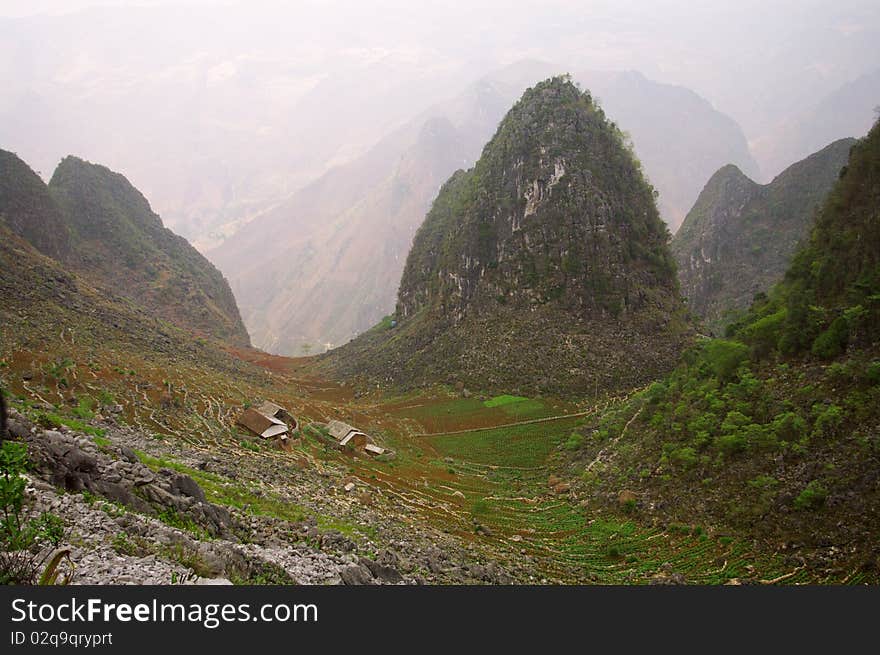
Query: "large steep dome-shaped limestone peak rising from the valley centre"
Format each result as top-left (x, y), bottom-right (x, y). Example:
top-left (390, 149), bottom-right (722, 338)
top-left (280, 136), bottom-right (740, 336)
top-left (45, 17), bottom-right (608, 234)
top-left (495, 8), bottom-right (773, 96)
top-left (323, 77), bottom-right (688, 393)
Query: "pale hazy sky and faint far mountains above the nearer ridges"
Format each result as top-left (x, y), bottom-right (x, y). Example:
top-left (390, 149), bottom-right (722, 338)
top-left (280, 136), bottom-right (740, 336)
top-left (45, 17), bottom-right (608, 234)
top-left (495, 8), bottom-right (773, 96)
top-left (0, 0), bottom-right (880, 238)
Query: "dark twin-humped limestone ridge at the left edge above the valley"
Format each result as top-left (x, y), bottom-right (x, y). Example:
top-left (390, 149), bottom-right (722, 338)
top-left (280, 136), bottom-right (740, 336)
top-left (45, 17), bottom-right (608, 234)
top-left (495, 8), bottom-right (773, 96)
top-left (0, 152), bottom-right (249, 345)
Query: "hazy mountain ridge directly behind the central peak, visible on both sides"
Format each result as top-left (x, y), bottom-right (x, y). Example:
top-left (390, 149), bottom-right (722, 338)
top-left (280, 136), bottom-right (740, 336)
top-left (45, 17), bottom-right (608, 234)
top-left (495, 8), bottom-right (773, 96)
top-left (208, 62), bottom-right (755, 354)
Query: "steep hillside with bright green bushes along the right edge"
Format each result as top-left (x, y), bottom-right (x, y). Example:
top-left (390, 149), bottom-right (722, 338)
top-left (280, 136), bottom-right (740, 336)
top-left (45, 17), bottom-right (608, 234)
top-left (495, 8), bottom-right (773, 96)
top-left (559, 120), bottom-right (880, 581)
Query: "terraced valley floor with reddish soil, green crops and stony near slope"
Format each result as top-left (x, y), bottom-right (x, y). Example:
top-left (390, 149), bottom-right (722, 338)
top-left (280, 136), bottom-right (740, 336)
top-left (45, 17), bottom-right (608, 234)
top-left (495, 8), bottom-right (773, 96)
top-left (0, 345), bottom-right (860, 584)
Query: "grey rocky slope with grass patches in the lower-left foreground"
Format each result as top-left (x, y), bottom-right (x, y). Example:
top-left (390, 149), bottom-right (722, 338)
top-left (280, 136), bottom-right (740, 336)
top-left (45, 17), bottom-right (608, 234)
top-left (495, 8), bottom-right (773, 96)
top-left (9, 410), bottom-right (519, 585)
